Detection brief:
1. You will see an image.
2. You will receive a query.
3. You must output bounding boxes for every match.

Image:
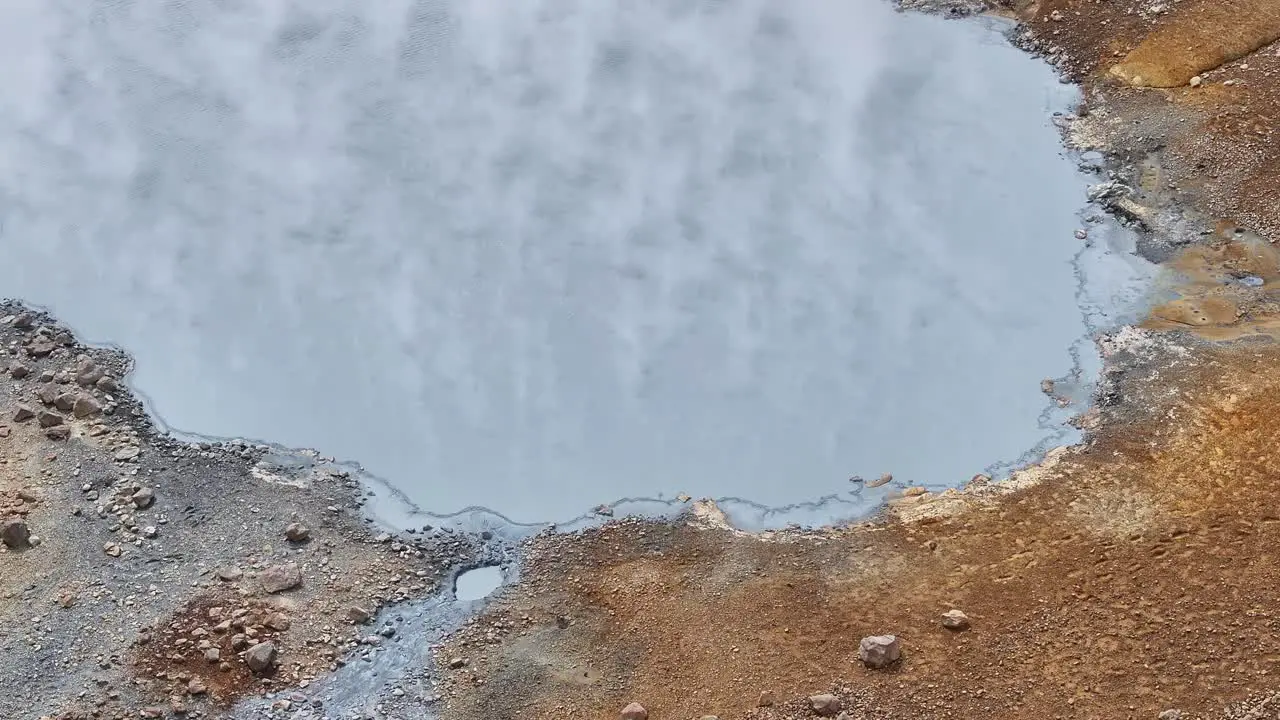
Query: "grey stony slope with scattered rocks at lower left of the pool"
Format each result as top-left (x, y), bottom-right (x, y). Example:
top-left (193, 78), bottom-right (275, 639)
top-left (0, 304), bottom-right (484, 720)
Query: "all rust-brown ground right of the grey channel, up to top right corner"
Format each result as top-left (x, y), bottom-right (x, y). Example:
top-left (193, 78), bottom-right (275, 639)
top-left (439, 0), bottom-right (1280, 720)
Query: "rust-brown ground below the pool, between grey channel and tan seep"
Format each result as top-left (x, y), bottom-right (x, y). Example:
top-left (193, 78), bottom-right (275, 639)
top-left (437, 335), bottom-right (1280, 717)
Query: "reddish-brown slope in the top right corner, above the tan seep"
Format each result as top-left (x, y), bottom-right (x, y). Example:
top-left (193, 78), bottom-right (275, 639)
top-left (1018, 0), bottom-right (1280, 241)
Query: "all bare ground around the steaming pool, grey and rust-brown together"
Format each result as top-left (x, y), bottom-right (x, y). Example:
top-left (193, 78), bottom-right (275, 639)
top-left (0, 0), bottom-right (1280, 720)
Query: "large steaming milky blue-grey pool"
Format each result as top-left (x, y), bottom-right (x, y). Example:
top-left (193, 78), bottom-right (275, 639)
top-left (0, 0), bottom-right (1148, 528)
